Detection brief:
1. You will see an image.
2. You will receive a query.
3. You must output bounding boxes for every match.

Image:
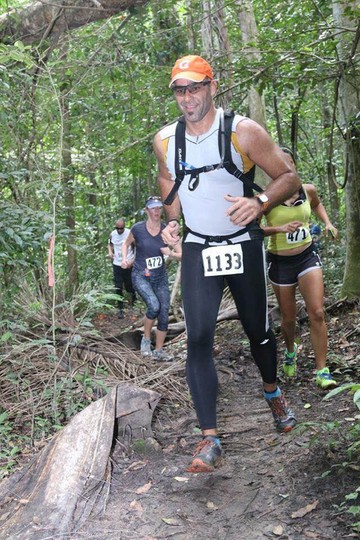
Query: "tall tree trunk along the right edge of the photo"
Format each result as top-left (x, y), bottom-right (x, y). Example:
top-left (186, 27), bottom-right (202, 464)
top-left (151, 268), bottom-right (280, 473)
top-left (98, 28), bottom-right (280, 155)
top-left (332, 0), bottom-right (360, 298)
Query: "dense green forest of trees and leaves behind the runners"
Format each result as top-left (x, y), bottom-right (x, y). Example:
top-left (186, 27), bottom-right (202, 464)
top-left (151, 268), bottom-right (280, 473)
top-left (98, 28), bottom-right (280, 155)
top-left (0, 0), bottom-right (360, 303)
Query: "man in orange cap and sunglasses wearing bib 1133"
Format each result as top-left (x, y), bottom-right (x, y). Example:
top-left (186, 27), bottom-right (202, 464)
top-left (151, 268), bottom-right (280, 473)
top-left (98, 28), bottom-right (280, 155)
top-left (154, 55), bottom-right (300, 472)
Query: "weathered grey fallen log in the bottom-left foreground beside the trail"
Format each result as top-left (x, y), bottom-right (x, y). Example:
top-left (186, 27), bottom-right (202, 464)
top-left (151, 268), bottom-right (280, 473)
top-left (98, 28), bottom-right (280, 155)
top-left (0, 383), bottom-right (160, 540)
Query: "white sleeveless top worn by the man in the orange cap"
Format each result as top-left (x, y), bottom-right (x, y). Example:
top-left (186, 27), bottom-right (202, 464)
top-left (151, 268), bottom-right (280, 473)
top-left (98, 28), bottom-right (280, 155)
top-left (160, 109), bottom-right (250, 245)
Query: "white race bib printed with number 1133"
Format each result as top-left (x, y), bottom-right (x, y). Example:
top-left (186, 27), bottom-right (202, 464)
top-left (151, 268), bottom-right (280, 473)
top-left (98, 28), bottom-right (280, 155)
top-left (202, 244), bottom-right (244, 277)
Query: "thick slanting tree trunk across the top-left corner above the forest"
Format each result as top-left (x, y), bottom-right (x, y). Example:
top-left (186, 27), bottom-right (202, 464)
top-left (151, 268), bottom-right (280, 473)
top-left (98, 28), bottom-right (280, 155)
top-left (0, 0), bottom-right (148, 44)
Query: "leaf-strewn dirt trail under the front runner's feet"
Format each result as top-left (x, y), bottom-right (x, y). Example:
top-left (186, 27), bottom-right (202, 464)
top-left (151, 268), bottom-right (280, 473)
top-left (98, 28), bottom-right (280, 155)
top-left (75, 321), bottom-right (358, 540)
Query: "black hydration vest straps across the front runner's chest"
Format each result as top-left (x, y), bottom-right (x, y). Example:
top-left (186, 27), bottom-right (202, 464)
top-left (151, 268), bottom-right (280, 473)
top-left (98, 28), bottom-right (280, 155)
top-left (164, 111), bottom-right (263, 205)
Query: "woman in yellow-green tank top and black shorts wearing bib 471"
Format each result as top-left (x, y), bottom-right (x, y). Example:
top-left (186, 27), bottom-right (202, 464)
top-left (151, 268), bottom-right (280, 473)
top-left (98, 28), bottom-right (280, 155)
top-left (262, 150), bottom-right (338, 389)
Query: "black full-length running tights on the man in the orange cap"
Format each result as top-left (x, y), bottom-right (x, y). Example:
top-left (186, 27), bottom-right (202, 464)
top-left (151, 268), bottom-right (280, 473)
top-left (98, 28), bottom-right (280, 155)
top-left (182, 239), bottom-right (276, 429)
